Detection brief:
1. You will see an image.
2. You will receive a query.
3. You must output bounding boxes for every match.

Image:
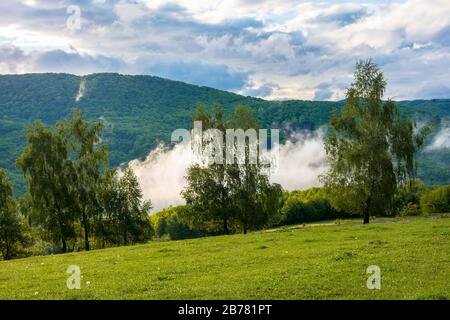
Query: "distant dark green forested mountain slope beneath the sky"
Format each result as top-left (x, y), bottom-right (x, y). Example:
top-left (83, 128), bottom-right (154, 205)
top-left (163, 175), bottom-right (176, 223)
top-left (0, 74), bottom-right (450, 190)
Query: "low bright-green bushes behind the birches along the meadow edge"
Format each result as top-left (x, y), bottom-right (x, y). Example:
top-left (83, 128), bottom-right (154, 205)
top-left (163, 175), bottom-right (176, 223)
top-left (150, 179), bottom-right (450, 240)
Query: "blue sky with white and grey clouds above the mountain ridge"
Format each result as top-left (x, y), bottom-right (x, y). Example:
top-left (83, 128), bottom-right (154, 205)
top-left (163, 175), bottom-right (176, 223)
top-left (0, 0), bottom-right (450, 100)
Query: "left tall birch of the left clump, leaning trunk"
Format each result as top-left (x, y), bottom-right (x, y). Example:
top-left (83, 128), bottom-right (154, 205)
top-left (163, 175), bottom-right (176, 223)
top-left (17, 122), bottom-right (76, 252)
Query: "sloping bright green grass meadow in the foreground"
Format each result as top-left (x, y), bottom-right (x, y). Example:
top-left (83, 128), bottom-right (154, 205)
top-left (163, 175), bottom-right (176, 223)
top-left (0, 218), bottom-right (450, 299)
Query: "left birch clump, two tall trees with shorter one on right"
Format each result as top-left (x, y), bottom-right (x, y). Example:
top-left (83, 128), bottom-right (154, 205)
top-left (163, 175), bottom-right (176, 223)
top-left (17, 113), bottom-right (151, 252)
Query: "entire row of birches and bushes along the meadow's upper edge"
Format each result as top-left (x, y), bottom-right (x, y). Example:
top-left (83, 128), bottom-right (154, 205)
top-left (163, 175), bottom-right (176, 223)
top-left (0, 60), bottom-right (449, 259)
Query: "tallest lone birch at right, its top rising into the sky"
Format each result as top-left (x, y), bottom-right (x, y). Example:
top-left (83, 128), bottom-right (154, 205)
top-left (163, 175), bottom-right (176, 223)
top-left (322, 60), bottom-right (425, 223)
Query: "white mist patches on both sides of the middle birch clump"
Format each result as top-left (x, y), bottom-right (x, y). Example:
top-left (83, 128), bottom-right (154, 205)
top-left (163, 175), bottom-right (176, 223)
top-left (129, 130), bottom-right (326, 212)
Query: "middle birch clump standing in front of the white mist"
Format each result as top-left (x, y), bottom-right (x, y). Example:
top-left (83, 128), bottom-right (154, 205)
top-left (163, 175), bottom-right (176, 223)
top-left (182, 106), bottom-right (282, 234)
